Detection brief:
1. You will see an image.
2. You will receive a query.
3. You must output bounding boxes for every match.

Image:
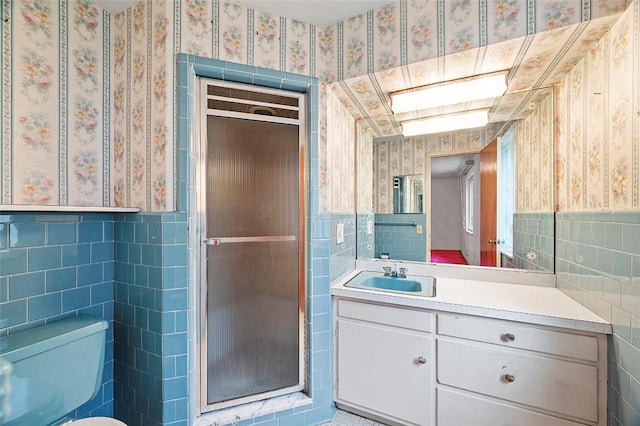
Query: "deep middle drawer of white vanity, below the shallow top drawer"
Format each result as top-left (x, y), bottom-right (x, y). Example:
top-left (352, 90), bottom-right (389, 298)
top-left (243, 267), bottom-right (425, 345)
top-left (436, 339), bottom-right (598, 422)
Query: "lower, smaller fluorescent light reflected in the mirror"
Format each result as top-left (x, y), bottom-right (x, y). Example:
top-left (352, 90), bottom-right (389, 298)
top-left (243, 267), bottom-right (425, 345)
top-left (402, 109), bottom-right (489, 136)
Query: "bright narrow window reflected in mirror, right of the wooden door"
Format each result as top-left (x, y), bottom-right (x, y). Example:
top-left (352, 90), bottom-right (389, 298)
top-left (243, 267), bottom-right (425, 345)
top-left (498, 125), bottom-right (516, 257)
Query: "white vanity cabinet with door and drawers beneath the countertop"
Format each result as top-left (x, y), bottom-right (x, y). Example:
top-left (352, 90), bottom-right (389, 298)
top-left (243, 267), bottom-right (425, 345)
top-left (334, 298), bottom-right (607, 426)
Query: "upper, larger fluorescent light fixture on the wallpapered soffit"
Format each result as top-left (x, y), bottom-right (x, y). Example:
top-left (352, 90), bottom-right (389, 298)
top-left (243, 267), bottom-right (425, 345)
top-left (389, 71), bottom-right (507, 114)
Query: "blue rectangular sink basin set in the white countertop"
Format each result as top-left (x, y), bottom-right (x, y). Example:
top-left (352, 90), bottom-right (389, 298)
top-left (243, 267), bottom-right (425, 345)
top-left (345, 271), bottom-right (436, 297)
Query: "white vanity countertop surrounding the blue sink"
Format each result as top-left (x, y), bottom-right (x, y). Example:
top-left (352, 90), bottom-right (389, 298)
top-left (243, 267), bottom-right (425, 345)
top-left (331, 270), bottom-right (612, 334)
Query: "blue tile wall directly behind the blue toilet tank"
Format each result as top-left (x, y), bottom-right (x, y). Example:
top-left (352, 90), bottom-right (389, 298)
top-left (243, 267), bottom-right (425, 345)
top-left (0, 212), bottom-right (114, 418)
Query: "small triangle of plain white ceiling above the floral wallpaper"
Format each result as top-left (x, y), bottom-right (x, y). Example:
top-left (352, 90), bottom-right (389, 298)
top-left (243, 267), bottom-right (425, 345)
top-left (233, 0), bottom-right (390, 25)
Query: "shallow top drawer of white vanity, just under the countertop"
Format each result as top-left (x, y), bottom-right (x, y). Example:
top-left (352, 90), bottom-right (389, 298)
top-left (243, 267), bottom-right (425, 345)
top-left (438, 314), bottom-right (598, 362)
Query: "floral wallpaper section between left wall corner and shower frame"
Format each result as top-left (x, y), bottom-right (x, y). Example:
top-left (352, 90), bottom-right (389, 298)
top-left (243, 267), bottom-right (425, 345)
top-left (111, 0), bottom-right (175, 211)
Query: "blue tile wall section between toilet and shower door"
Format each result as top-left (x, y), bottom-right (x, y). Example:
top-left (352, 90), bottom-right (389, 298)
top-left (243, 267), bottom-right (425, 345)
top-left (114, 213), bottom-right (188, 426)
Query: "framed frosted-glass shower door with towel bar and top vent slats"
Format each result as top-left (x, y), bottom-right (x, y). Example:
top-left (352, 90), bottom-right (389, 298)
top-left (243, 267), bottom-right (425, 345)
top-left (196, 79), bottom-right (306, 411)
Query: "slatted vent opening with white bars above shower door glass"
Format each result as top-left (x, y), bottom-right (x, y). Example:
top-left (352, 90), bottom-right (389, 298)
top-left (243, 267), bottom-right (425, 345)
top-left (206, 82), bottom-right (300, 124)
